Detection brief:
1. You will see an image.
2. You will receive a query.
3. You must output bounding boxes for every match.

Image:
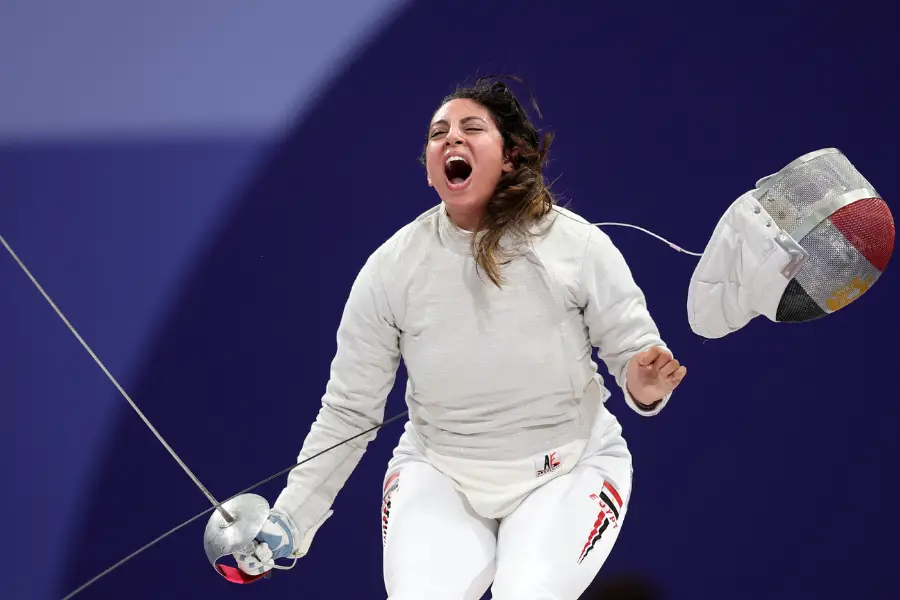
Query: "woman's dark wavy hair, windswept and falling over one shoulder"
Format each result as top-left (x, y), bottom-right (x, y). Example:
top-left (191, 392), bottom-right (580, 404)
top-left (419, 75), bottom-right (556, 287)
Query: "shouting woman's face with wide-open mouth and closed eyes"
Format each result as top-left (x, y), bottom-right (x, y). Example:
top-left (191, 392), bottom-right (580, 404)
top-left (425, 99), bottom-right (512, 225)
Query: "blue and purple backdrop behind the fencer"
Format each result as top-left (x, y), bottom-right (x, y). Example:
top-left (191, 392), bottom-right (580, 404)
top-left (0, 0), bottom-right (900, 600)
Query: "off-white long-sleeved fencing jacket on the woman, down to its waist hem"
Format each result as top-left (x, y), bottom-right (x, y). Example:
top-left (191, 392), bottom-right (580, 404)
top-left (274, 204), bottom-right (669, 548)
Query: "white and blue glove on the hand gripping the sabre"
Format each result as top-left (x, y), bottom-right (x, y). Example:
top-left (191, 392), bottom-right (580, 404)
top-left (234, 510), bottom-right (334, 575)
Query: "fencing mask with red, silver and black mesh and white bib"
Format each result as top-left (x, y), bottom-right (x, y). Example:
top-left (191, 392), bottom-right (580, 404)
top-left (687, 148), bottom-right (894, 338)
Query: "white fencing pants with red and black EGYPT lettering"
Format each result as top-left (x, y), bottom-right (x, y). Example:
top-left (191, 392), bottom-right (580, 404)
top-left (381, 409), bottom-right (631, 600)
